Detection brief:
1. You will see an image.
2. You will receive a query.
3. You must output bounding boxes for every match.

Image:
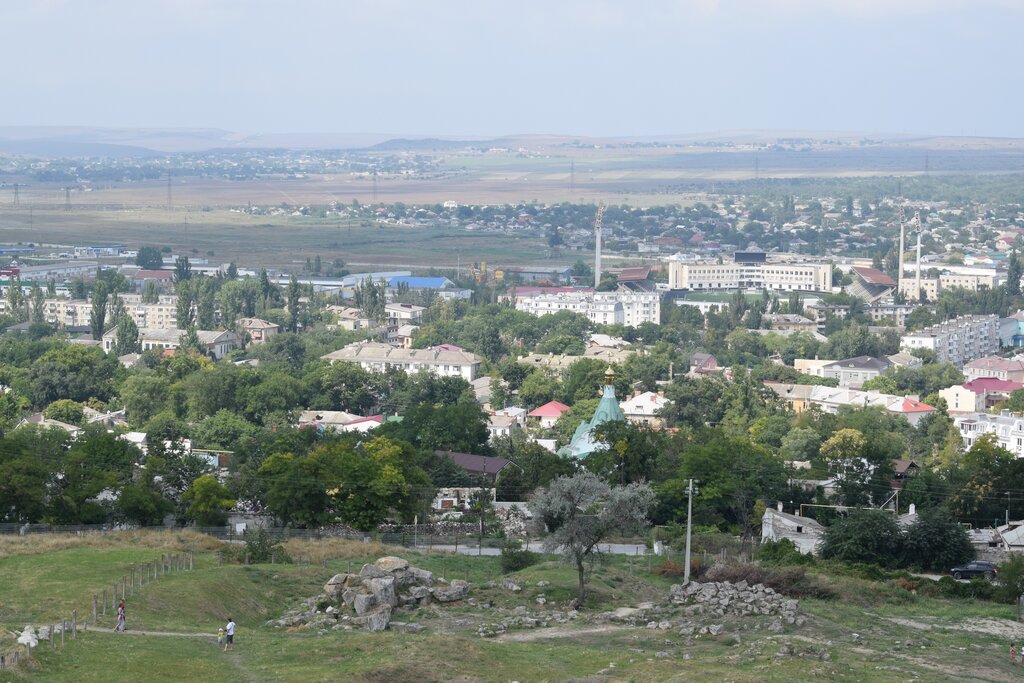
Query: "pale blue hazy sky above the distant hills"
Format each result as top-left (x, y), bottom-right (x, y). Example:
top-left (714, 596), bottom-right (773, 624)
top-left (0, 0), bottom-right (1024, 136)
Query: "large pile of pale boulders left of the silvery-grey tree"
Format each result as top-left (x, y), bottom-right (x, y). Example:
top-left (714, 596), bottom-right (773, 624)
top-left (267, 556), bottom-right (469, 631)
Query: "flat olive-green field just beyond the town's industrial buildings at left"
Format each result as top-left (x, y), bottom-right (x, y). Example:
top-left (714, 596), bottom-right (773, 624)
top-left (0, 208), bottom-right (561, 269)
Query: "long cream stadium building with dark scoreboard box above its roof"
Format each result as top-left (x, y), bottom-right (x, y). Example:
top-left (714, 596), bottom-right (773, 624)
top-left (669, 259), bottom-right (831, 292)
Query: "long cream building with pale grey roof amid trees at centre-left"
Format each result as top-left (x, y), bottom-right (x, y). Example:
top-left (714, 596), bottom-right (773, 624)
top-left (321, 342), bottom-right (482, 382)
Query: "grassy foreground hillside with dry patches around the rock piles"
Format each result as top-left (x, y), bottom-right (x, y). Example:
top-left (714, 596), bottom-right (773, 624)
top-left (0, 535), bottom-right (1024, 683)
